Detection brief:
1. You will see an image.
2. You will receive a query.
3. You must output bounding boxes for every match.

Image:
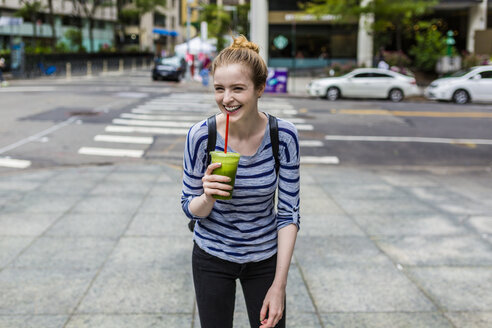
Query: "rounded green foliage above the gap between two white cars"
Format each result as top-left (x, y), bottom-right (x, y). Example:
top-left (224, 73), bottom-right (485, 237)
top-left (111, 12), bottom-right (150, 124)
top-left (410, 22), bottom-right (447, 72)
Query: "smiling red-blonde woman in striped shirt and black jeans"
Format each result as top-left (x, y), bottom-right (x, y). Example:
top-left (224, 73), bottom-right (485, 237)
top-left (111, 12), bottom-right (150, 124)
top-left (181, 36), bottom-right (300, 328)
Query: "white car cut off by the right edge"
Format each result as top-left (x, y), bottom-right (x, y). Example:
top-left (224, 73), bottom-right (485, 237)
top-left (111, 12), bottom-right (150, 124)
top-left (424, 65), bottom-right (492, 104)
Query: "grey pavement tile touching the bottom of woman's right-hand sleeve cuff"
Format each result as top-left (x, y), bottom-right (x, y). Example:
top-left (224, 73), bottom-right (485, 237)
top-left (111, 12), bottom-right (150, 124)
top-left (299, 213), bottom-right (364, 237)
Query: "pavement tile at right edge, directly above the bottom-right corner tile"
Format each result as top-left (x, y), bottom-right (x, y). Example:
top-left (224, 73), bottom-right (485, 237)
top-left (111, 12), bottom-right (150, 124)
top-left (407, 267), bottom-right (492, 312)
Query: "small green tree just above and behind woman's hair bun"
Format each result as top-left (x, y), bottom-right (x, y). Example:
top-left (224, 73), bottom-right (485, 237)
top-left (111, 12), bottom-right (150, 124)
top-left (200, 4), bottom-right (232, 52)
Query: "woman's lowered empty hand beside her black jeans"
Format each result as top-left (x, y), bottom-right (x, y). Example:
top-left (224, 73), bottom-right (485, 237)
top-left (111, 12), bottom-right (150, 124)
top-left (260, 285), bottom-right (285, 328)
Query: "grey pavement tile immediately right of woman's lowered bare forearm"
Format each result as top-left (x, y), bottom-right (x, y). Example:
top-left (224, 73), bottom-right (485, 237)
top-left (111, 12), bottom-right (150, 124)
top-left (295, 235), bottom-right (390, 271)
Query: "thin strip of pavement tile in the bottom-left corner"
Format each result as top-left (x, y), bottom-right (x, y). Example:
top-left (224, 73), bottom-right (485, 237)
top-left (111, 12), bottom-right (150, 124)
top-left (0, 315), bottom-right (68, 328)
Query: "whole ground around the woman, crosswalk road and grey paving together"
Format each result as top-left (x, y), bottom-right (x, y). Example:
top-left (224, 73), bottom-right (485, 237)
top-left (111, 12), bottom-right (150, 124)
top-left (0, 71), bottom-right (492, 328)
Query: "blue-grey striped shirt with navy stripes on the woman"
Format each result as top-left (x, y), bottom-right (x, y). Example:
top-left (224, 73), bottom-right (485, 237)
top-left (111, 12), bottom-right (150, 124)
top-left (181, 114), bottom-right (300, 263)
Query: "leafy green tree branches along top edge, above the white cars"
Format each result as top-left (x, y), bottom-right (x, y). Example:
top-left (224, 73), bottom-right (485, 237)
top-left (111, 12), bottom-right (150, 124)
top-left (303, 0), bottom-right (438, 51)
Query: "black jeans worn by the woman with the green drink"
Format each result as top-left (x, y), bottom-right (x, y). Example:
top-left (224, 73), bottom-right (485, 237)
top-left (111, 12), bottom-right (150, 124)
top-left (192, 244), bottom-right (285, 328)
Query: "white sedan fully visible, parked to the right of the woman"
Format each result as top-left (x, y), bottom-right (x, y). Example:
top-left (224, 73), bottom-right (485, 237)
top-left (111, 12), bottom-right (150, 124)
top-left (306, 68), bottom-right (420, 101)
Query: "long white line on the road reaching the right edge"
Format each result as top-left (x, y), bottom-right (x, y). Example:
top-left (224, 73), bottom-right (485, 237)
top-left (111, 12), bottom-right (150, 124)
top-left (325, 135), bottom-right (492, 145)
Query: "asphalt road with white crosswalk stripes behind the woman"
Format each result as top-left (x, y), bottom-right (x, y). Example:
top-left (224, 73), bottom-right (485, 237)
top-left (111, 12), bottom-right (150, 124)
top-left (0, 71), bottom-right (492, 174)
